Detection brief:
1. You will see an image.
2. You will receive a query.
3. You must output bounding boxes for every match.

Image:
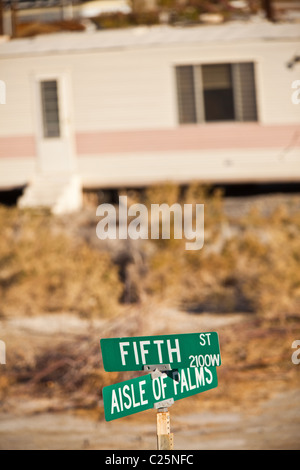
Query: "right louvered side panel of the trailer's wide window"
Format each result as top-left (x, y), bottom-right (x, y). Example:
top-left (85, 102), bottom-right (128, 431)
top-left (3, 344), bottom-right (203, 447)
top-left (232, 62), bottom-right (257, 121)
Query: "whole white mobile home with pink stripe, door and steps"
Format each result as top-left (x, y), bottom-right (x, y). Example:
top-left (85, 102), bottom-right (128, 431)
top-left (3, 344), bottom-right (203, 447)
top-left (0, 21), bottom-right (300, 212)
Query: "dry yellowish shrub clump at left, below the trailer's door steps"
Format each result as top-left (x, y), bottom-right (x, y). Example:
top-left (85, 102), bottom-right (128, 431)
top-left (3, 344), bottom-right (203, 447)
top-left (0, 207), bottom-right (122, 316)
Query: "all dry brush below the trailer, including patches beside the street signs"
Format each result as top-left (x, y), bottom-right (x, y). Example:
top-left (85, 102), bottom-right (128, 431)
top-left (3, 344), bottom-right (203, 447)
top-left (0, 184), bottom-right (300, 414)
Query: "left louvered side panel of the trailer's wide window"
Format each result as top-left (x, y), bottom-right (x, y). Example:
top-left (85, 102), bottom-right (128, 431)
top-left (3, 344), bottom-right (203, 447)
top-left (176, 65), bottom-right (197, 124)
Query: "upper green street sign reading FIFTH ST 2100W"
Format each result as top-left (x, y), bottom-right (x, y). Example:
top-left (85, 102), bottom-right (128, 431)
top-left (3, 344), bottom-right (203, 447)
top-left (100, 332), bottom-right (221, 372)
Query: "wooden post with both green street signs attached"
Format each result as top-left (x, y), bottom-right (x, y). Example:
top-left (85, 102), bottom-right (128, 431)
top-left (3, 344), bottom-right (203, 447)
top-left (100, 332), bottom-right (221, 450)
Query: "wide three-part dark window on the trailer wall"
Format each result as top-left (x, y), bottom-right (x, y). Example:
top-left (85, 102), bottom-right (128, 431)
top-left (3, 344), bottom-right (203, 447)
top-left (176, 62), bottom-right (257, 124)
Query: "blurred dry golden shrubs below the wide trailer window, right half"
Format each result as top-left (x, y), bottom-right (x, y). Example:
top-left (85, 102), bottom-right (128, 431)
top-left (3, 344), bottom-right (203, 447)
top-left (138, 184), bottom-right (300, 316)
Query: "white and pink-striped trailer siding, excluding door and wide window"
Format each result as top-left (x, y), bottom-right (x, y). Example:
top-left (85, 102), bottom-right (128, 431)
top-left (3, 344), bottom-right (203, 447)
top-left (0, 23), bottom-right (300, 187)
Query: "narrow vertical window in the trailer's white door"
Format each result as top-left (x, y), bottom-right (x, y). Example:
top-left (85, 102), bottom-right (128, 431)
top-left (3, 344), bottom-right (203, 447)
top-left (41, 80), bottom-right (60, 138)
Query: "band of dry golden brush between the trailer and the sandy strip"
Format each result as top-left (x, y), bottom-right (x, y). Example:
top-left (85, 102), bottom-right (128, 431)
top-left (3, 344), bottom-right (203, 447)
top-left (0, 185), bottom-right (300, 317)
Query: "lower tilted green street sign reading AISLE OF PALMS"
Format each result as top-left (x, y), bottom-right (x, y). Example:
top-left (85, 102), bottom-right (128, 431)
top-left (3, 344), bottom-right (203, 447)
top-left (103, 367), bottom-right (218, 421)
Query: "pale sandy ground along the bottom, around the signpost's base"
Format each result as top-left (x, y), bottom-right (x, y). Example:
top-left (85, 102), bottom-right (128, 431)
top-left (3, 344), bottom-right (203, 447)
top-left (0, 390), bottom-right (300, 450)
